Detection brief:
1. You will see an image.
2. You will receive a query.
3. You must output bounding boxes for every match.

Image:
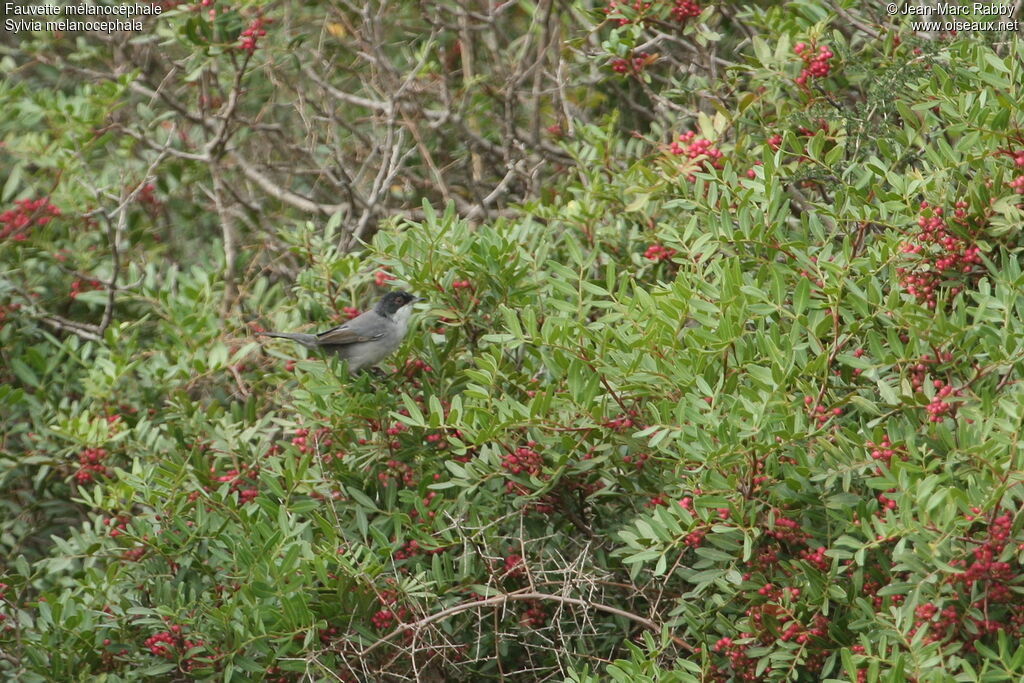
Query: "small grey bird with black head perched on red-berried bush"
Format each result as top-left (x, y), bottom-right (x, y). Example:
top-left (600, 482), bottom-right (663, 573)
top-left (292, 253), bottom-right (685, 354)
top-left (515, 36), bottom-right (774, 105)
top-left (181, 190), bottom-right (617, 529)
top-left (260, 290), bottom-right (423, 373)
